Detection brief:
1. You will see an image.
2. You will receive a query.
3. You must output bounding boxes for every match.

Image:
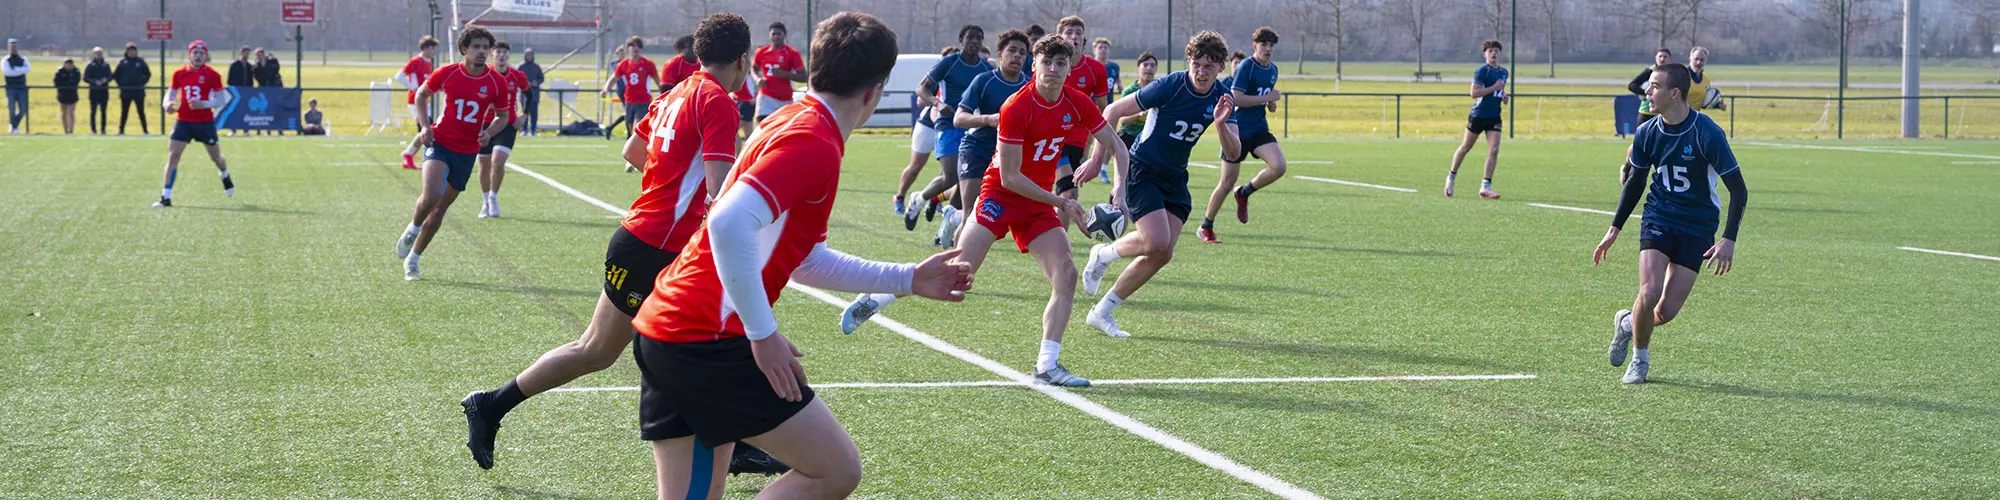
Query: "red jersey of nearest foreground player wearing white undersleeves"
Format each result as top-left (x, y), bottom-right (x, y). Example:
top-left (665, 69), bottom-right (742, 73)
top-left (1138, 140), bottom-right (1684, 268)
top-left (632, 94), bottom-right (846, 344)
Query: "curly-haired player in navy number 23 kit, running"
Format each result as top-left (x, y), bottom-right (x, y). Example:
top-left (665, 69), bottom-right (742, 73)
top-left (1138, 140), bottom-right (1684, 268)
top-left (1076, 32), bottom-right (1242, 336)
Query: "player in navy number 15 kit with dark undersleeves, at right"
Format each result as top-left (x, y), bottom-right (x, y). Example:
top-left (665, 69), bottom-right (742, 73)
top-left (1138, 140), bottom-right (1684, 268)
top-left (1590, 64), bottom-right (1750, 384)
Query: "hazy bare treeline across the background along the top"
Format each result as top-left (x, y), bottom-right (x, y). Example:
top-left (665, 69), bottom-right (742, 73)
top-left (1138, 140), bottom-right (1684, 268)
top-left (0, 0), bottom-right (2000, 74)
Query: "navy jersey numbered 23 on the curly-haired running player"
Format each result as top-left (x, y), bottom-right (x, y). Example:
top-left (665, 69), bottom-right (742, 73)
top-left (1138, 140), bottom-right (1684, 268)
top-left (1132, 72), bottom-right (1230, 182)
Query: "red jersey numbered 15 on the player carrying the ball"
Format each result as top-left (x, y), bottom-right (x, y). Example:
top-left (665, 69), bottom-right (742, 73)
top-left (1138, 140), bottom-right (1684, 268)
top-left (980, 84), bottom-right (1104, 205)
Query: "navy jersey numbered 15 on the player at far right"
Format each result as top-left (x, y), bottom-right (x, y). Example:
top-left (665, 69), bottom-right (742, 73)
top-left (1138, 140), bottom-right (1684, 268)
top-left (1626, 110), bottom-right (1738, 234)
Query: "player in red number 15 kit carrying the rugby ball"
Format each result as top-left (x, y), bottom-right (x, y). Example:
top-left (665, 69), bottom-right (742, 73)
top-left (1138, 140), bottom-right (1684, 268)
top-left (840, 32), bottom-right (1130, 388)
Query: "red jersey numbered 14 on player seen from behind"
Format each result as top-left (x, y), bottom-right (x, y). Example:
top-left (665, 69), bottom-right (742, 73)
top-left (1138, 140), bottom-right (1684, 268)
top-left (622, 72), bottom-right (736, 254)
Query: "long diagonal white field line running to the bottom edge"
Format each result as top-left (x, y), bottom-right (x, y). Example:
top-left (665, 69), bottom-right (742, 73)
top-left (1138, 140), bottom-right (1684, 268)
top-left (508, 162), bottom-right (1320, 500)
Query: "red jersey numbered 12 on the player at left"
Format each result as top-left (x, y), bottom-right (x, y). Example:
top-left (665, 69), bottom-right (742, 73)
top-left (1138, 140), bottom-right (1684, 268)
top-left (424, 62), bottom-right (514, 154)
